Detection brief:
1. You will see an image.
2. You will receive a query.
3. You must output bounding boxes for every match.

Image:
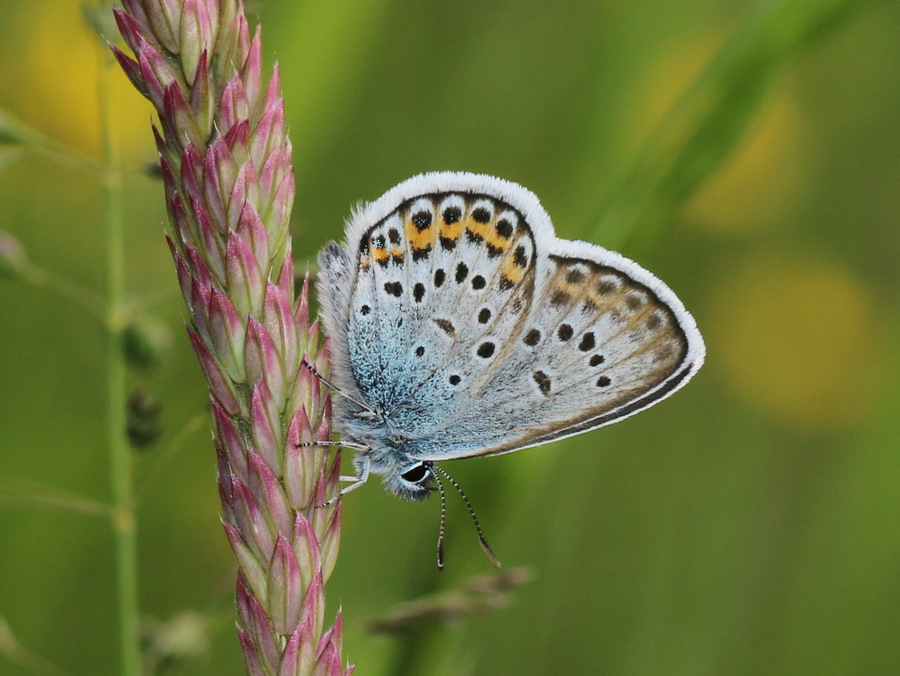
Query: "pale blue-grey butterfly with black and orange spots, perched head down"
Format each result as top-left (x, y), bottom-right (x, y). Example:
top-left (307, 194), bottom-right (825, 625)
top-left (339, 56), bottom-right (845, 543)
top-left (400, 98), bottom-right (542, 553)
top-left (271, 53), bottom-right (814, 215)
top-left (318, 172), bottom-right (705, 556)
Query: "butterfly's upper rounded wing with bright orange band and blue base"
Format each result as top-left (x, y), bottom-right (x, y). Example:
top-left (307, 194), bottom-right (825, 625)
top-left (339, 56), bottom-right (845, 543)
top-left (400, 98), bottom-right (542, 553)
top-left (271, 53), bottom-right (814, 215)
top-left (336, 193), bottom-right (535, 436)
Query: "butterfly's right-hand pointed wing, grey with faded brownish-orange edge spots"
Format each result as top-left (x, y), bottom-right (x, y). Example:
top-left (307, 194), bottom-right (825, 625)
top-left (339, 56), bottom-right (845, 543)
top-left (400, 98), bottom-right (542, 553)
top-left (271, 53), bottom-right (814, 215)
top-left (423, 240), bottom-right (699, 459)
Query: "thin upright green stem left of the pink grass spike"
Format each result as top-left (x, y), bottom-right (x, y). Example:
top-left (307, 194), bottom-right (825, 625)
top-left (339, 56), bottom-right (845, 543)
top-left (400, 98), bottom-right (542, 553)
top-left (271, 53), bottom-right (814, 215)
top-left (98, 26), bottom-right (141, 676)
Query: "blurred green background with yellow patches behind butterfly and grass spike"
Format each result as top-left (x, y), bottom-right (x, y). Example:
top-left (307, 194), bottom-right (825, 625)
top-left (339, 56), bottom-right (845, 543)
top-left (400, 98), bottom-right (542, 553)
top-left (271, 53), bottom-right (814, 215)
top-left (0, 0), bottom-right (900, 676)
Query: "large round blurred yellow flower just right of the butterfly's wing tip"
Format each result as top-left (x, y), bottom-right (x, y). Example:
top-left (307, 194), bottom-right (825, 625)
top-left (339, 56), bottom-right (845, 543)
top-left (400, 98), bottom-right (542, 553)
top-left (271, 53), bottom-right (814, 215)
top-left (705, 253), bottom-right (879, 430)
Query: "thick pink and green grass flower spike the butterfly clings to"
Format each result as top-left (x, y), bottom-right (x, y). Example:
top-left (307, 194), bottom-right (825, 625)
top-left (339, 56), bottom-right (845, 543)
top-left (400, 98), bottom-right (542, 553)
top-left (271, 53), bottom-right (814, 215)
top-left (112, 0), bottom-right (353, 676)
